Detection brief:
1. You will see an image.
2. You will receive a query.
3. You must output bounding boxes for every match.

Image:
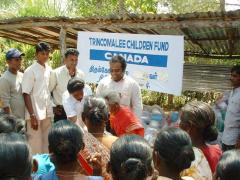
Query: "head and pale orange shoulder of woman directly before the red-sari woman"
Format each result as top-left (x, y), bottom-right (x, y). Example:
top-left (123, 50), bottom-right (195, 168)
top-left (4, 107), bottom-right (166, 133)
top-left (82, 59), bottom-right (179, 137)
top-left (82, 97), bottom-right (117, 149)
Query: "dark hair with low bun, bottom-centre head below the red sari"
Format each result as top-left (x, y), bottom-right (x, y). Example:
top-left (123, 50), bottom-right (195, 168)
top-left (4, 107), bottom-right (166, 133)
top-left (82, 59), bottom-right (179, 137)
top-left (110, 135), bottom-right (152, 180)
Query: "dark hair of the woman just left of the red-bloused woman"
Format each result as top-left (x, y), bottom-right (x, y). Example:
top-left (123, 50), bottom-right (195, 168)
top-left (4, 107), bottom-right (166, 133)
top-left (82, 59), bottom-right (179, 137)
top-left (154, 128), bottom-right (195, 173)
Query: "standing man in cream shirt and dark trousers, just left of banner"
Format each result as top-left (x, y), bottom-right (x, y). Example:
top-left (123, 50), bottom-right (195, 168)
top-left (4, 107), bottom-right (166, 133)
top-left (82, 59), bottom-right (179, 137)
top-left (50, 48), bottom-right (84, 122)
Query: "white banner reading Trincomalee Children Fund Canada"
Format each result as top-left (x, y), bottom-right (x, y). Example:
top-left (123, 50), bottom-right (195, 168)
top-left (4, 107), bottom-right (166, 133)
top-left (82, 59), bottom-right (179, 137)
top-left (77, 32), bottom-right (184, 95)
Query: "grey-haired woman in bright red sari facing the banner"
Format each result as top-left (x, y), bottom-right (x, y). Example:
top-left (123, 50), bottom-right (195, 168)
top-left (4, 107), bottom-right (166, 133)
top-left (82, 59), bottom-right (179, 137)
top-left (105, 92), bottom-right (144, 137)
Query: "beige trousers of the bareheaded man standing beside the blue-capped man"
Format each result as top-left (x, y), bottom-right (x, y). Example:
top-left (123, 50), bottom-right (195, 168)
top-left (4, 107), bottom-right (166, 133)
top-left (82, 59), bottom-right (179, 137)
top-left (27, 118), bottom-right (52, 154)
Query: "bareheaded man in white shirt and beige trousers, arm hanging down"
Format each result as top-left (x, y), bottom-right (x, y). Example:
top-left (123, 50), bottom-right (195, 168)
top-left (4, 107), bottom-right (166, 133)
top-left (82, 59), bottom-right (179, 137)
top-left (22, 42), bottom-right (53, 154)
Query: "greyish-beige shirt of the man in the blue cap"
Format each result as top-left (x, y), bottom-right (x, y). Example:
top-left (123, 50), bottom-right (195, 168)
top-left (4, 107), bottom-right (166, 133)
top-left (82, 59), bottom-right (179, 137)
top-left (0, 70), bottom-right (25, 119)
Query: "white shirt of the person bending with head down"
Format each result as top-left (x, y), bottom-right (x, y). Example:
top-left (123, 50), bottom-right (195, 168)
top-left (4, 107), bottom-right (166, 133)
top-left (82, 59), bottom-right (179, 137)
top-left (62, 84), bottom-right (92, 119)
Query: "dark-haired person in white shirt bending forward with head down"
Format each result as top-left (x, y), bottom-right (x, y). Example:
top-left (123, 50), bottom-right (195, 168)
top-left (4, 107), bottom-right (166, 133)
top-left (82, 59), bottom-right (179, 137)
top-left (62, 77), bottom-right (92, 129)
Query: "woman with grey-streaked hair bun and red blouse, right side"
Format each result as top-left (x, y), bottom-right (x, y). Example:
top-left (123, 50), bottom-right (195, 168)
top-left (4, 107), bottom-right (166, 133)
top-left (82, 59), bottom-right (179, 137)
top-left (179, 101), bottom-right (222, 173)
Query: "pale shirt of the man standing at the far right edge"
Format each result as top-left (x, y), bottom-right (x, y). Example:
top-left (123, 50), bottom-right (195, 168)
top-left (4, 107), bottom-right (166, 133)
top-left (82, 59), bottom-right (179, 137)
top-left (222, 87), bottom-right (240, 145)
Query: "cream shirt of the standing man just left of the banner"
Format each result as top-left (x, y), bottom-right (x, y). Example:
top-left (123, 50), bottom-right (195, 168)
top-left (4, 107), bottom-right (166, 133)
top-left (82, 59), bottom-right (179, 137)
top-left (50, 65), bottom-right (84, 105)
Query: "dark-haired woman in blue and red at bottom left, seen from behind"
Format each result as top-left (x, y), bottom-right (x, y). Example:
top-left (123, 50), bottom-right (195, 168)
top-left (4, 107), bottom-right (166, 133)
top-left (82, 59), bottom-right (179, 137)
top-left (34, 120), bottom-right (103, 180)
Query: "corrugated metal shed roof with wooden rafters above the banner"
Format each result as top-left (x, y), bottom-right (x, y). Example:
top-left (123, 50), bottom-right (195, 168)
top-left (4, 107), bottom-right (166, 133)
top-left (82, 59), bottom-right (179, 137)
top-left (0, 10), bottom-right (240, 59)
